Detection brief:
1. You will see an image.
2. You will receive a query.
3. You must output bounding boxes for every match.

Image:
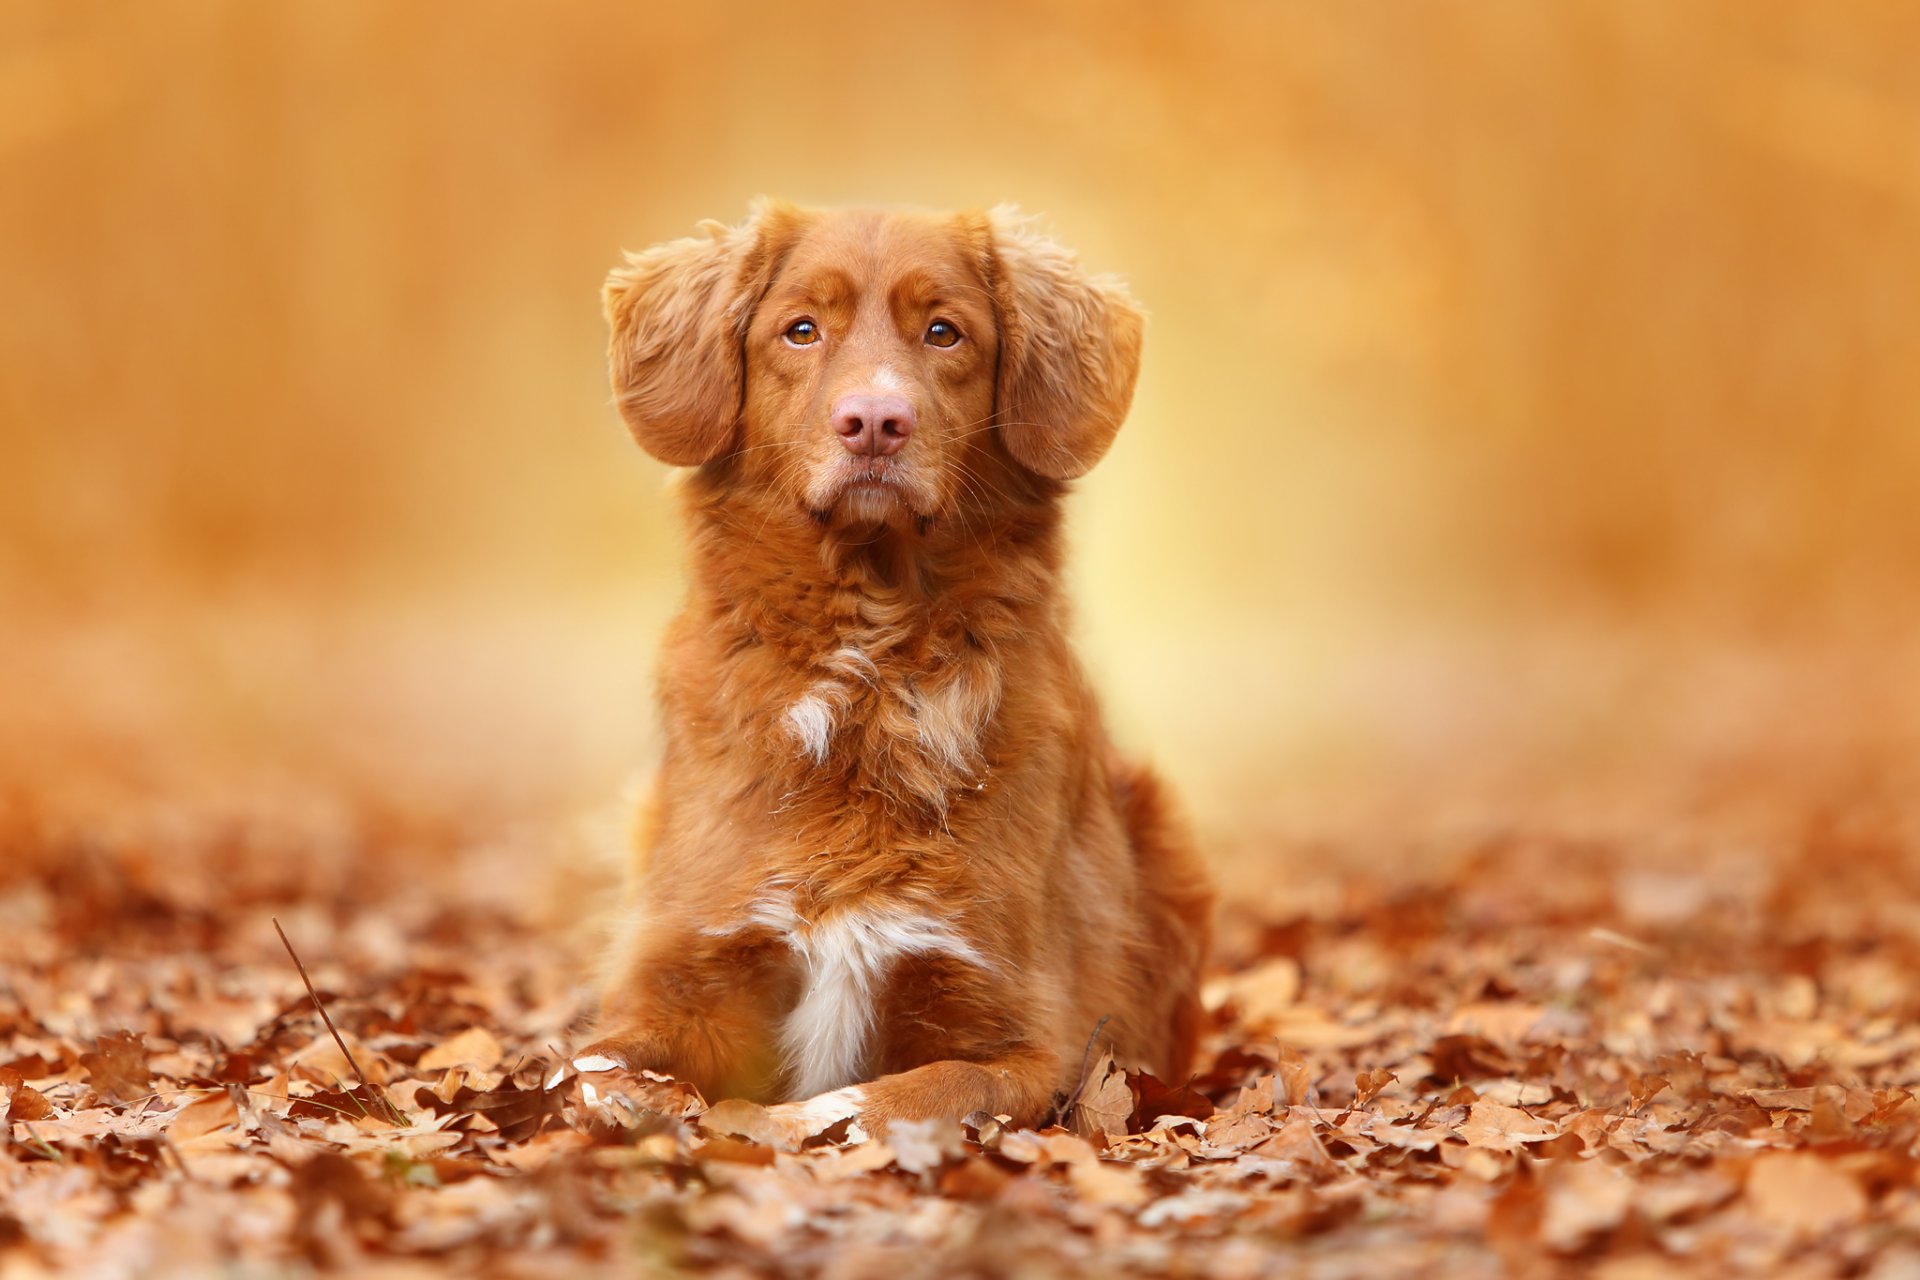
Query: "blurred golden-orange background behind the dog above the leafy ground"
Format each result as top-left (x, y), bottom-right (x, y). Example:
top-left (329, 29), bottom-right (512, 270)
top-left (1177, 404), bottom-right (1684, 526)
top-left (0, 0), bottom-right (1920, 875)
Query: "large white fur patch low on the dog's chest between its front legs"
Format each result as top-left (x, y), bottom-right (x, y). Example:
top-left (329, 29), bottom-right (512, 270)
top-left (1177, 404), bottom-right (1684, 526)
top-left (733, 892), bottom-right (991, 1098)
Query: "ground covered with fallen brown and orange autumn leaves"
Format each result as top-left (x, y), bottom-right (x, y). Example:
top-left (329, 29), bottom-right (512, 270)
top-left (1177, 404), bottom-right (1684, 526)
top-left (0, 782), bottom-right (1920, 1280)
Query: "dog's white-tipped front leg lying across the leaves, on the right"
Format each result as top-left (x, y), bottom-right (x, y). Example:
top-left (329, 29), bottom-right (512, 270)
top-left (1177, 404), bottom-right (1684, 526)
top-left (770, 1050), bottom-right (1060, 1136)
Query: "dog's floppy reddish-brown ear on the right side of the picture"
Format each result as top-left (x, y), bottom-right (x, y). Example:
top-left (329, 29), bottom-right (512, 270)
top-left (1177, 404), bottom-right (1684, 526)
top-left (987, 205), bottom-right (1146, 480)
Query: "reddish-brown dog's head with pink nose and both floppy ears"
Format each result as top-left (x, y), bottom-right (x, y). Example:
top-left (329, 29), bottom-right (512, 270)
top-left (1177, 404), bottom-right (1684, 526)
top-left (605, 203), bottom-right (1142, 528)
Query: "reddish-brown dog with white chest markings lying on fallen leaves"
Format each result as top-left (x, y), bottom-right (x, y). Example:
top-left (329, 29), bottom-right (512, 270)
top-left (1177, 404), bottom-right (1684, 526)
top-left (576, 201), bottom-right (1212, 1132)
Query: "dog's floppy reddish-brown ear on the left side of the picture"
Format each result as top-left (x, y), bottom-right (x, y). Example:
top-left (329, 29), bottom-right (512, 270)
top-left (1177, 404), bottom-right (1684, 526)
top-left (601, 201), bottom-right (799, 466)
